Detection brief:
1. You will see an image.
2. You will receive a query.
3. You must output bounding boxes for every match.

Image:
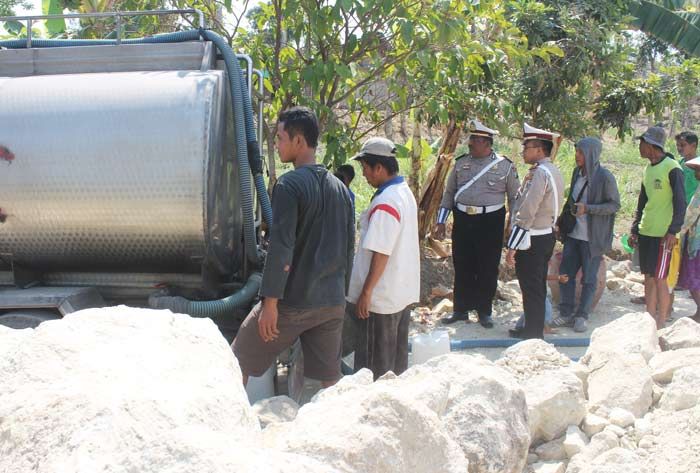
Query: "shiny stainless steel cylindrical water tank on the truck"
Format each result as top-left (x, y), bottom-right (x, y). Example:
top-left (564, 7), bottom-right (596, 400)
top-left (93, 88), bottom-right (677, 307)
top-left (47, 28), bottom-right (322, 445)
top-left (0, 70), bottom-right (242, 274)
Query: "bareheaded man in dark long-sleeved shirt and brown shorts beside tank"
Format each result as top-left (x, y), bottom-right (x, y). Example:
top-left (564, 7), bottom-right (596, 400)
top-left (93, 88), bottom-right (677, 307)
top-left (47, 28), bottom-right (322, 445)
top-left (233, 107), bottom-right (355, 386)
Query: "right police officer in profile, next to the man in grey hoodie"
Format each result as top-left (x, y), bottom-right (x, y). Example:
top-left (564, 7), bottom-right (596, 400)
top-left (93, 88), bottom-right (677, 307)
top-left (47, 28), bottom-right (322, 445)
top-left (506, 123), bottom-right (564, 338)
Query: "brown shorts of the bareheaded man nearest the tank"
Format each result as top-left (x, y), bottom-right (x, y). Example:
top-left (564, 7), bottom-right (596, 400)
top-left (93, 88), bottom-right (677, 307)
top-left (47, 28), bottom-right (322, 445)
top-left (231, 303), bottom-right (345, 381)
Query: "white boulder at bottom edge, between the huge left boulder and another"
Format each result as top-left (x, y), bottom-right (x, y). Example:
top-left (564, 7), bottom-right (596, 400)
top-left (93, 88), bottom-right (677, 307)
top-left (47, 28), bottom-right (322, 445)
top-left (263, 383), bottom-right (468, 473)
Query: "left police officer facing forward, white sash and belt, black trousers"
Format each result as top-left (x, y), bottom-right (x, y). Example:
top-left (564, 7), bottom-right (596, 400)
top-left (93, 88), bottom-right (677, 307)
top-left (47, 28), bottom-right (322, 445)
top-left (435, 120), bottom-right (519, 328)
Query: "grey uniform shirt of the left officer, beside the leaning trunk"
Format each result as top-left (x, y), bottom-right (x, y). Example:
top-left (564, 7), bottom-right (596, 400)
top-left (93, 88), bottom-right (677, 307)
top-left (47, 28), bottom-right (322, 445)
top-left (440, 152), bottom-right (519, 210)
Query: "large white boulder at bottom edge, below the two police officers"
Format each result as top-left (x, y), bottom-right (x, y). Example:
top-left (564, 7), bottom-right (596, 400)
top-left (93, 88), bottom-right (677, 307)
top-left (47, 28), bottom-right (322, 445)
top-left (416, 354), bottom-right (530, 473)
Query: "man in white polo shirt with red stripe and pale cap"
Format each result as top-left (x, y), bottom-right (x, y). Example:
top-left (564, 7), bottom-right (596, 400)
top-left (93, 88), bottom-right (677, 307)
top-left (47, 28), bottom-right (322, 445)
top-left (346, 138), bottom-right (420, 379)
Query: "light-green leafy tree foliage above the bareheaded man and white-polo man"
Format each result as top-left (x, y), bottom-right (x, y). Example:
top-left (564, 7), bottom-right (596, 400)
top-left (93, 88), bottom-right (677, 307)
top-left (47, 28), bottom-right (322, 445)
top-left (237, 0), bottom-right (560, 167)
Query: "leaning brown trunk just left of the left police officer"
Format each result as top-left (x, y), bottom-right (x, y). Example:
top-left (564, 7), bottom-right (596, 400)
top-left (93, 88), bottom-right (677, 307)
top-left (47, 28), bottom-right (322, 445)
top-left (418, 120), bottom-right (462, 240)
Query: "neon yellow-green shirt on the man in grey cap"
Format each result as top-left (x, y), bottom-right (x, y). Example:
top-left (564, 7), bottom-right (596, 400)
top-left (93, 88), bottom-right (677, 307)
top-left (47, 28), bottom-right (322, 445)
top-left (639, 157), bottom-right (680, 237)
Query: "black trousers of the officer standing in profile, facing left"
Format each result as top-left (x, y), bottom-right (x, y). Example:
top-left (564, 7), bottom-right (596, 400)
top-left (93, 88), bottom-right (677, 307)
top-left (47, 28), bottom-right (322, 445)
top-left (515, 233), bottom-right (555, 338)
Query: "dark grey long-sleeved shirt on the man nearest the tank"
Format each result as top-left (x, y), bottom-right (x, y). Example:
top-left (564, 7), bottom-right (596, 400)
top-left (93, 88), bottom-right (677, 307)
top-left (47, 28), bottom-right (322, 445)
top-left (260, 164), bottom-right (355, 309)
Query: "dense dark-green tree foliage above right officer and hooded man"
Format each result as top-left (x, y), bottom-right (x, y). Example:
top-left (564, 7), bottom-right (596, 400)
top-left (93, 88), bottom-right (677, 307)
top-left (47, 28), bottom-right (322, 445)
top-left (510, 0), bottom-right (628, 137)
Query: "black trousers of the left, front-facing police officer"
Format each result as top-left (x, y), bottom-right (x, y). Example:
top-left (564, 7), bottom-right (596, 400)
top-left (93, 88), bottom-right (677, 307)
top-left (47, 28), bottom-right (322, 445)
top-left (452, 207), bottom-right (506, 316)
